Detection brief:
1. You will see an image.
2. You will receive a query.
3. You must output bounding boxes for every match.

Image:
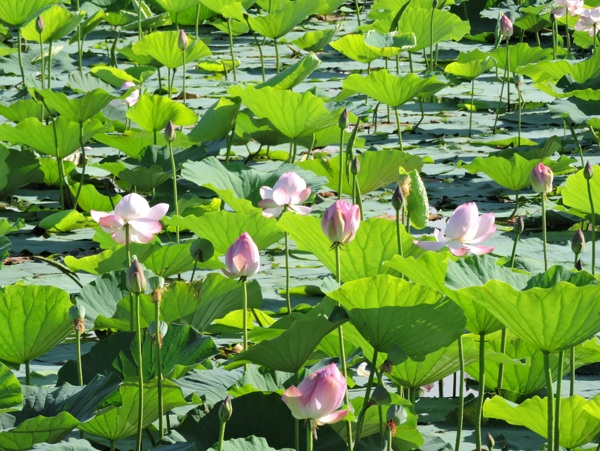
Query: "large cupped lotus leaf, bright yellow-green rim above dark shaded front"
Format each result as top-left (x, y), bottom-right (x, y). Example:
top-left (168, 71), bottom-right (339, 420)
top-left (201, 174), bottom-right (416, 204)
top-left (328, 275), bottom-right (465, 357)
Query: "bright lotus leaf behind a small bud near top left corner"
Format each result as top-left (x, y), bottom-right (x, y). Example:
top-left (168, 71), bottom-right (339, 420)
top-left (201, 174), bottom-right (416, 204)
top-left (21, 2), bottom-right (85, 43)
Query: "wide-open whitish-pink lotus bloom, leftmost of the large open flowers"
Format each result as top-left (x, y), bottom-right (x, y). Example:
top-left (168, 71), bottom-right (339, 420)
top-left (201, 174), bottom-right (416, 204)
top-left (90, 193), bottom-right (169, 244)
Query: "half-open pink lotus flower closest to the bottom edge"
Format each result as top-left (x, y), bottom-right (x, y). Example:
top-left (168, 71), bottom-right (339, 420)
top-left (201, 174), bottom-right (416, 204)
top-left (282, 363), bottom-right (348, 426)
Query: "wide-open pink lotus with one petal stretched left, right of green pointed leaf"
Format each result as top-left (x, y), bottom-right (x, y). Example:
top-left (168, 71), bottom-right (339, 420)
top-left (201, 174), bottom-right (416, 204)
top-left (415, 202), bottom-right (496, 257)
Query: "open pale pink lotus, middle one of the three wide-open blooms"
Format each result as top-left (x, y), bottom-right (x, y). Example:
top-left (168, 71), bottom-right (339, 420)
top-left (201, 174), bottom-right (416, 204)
top-left (258, 172), bottom-right (310, 218)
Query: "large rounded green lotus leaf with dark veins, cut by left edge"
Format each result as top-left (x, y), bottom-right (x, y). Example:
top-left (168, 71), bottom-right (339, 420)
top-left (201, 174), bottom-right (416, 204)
top-left (0, 285), bottom-right (73, 364)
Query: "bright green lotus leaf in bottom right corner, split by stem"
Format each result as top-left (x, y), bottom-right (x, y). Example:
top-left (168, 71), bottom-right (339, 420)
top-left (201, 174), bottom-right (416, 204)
top-left (483, 395), bottom-right (600, 449)
